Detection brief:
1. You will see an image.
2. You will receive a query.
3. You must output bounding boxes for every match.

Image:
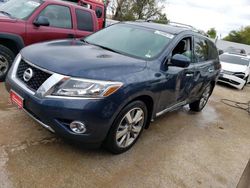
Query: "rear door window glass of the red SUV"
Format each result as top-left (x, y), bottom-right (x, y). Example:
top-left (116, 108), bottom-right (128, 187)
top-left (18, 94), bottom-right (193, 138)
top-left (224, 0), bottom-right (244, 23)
top-left (76, 9), bottom-right (94, 32)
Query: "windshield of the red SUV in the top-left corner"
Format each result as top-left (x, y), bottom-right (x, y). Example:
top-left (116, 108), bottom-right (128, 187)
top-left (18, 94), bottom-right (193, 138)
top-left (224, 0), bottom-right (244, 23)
top-left (0, 0), bottom-right (43, 20)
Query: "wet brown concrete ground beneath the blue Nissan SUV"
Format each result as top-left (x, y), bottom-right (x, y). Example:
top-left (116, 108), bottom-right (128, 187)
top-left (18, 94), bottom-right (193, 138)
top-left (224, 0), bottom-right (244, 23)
top-left (0, 83), bottom-right (250, 188)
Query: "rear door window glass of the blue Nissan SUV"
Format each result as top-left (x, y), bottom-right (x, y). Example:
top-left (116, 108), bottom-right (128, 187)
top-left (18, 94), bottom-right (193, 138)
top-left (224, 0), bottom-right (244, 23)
top-left (194, 38), bottom-right (209, 62)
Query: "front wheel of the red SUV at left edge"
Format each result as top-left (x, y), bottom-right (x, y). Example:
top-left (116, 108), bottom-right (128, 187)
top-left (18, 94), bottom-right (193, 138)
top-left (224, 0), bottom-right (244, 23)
top-left (0, 45), bottom-right (15, 82)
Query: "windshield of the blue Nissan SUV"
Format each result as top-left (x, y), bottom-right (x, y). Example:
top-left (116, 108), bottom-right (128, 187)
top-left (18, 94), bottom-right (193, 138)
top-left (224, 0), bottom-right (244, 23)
top-left (85, 24), bottom-right (174, 59)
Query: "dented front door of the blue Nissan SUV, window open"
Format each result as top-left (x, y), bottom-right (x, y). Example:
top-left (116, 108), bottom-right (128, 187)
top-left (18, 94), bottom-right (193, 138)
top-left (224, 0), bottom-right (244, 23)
top-left (156, 36), bottom-right (197, 111)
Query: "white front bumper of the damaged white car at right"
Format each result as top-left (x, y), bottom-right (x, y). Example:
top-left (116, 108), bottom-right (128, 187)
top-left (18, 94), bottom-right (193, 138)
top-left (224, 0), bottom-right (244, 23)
top-left (218, 73), bottom-right (246, 89)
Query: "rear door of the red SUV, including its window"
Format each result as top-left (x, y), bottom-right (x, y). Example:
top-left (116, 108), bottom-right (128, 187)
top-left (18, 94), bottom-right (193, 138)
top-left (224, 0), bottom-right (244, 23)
top-left (75, 9), bottom-right (94, 38)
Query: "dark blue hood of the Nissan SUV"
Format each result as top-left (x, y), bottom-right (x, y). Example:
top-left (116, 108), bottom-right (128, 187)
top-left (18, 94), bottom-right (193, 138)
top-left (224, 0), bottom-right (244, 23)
top-left (21, 40), bottom-right (146, 80)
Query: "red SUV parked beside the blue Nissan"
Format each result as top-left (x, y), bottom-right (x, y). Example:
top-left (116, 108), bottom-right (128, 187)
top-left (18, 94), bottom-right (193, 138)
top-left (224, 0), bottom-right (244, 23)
top-left (0, 0), bottom-right (98, 81)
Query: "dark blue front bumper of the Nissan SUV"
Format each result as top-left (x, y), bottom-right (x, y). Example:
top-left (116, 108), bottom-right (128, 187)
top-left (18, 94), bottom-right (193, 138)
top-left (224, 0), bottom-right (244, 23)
top-left (5, 76), bottom-right (118, 144)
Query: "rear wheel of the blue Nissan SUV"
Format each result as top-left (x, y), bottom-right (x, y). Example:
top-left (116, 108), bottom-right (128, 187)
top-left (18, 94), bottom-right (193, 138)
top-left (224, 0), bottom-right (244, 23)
top-left (189, 84), bottom-right (212, 112)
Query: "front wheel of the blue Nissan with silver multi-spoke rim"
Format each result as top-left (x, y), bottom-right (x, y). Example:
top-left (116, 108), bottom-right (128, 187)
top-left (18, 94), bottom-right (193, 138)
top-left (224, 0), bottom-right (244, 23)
top-left (104, 101), bottom-right (148, 154)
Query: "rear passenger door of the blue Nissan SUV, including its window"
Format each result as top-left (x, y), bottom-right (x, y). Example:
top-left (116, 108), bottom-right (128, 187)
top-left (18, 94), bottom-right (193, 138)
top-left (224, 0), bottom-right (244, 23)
top-left (191, 36), bottom-right (219, 98)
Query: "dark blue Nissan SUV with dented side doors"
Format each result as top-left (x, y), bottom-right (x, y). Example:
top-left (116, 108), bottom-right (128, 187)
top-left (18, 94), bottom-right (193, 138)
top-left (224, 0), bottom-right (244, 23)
top-left (6, 22), bottom-right (220, 153)
